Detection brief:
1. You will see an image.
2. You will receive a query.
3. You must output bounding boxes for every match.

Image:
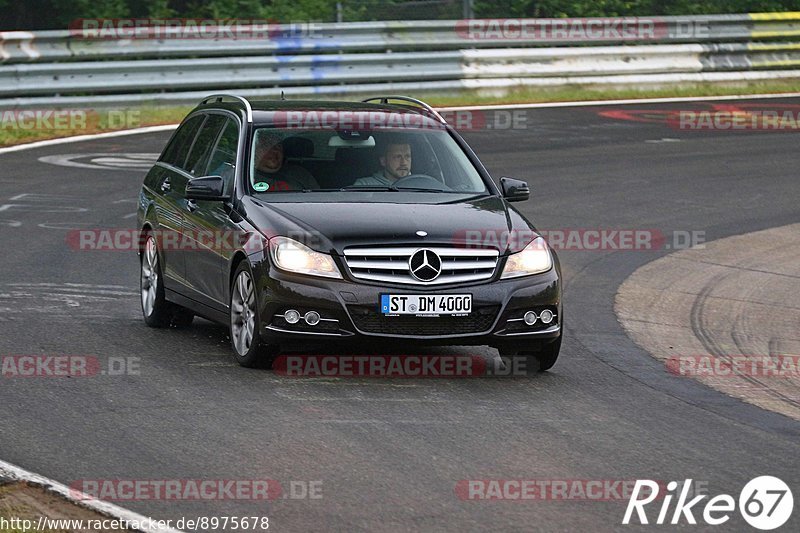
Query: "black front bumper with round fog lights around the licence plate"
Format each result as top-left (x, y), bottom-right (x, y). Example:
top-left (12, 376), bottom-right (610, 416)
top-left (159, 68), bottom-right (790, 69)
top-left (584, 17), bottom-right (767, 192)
top-left (254, 261), bottom-right (562, 351)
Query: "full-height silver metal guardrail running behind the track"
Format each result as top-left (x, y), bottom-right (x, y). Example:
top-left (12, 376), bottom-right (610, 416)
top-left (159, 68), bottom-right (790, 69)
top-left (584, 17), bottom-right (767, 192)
top-left (0, 13), bottom-right (800, 107)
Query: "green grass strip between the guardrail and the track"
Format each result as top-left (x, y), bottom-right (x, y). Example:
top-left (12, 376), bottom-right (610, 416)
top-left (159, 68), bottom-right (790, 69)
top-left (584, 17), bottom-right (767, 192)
top-left (0, 79), bottom-right (800, 147)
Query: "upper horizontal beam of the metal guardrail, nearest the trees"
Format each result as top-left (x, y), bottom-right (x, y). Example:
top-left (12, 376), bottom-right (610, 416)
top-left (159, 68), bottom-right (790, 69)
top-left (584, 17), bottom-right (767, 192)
top-left (0, 12), bottom-right (800, 63)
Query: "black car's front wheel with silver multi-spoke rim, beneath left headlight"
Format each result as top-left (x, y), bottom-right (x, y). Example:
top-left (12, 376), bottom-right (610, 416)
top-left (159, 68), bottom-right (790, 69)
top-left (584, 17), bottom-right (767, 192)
top-left (230, 261), bottom-right (271, 368)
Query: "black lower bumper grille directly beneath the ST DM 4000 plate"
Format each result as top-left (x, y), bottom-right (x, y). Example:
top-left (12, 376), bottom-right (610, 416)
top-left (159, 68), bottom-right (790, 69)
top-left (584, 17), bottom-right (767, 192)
top-left (348, 306), bottom-right (500, 337)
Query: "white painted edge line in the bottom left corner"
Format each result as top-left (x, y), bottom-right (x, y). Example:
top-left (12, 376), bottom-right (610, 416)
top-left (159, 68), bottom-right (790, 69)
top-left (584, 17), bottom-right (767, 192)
top-left (0, 461), bottom-right (182, 533)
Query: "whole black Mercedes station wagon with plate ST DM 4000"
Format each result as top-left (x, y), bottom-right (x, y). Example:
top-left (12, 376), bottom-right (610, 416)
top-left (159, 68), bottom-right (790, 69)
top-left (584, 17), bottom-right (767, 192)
top-left (138, 95), bottom-right (564, 370)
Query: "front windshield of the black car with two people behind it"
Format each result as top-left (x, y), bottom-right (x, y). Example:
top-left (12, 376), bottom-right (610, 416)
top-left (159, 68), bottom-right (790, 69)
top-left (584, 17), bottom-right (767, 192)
top-left (250, 119), bottom-right (488, 194)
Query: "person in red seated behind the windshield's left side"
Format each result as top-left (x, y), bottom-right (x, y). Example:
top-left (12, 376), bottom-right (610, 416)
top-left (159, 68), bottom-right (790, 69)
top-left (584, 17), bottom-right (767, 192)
top-left (253, 133), bottom-right (319, 192)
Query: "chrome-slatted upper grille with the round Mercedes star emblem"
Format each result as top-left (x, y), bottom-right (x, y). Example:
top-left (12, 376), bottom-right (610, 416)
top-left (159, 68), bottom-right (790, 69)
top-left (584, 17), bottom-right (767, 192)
top-left (344, 246), bottom-right (500, 285)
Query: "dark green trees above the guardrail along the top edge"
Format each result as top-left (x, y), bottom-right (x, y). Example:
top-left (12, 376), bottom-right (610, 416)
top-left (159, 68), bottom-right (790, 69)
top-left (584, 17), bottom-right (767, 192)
top-left (0, 0), bottom-right (800, 30)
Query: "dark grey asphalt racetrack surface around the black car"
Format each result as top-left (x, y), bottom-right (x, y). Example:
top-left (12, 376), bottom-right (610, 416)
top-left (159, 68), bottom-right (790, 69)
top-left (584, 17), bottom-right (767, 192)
top-left (0, 101), bottom-right (800, 531)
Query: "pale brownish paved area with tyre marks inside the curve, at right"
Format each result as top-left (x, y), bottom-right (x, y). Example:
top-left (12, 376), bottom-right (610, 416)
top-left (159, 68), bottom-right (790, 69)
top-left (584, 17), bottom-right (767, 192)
top-left (615, 224), bottom-right (800, 420)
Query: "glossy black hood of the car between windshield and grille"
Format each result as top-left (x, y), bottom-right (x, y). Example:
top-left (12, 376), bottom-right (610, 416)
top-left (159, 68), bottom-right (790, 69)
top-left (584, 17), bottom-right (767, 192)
top-left (242, 193), bottom-right (535, 255)
